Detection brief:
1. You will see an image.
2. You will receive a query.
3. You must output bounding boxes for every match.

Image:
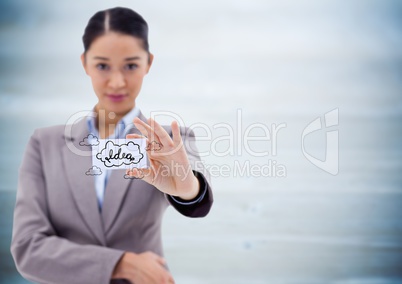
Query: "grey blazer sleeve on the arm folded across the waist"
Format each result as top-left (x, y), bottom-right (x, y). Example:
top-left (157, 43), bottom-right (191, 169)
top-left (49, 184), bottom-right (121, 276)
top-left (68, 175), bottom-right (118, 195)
top-left (11, 131), bottom-right (124, 284)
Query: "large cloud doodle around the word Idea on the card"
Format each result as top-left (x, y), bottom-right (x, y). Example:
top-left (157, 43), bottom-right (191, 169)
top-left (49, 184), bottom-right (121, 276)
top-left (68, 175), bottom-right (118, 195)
top-left (96, 141), bottom-right (144, 168)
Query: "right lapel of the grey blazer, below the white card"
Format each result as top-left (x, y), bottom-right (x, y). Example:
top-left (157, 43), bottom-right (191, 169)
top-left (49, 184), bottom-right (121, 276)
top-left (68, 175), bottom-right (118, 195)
top-left (102, 112), bottom-right (147, 234)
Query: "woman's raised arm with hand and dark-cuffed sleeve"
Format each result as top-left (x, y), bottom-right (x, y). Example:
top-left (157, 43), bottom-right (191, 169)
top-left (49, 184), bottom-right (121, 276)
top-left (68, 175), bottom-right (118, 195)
top-left (127, 118), bottom-right (213, 217)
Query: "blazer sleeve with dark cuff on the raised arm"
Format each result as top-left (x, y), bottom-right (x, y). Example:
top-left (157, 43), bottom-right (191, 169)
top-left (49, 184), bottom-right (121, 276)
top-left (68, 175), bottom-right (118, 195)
top-left (165, 128), bottom-right (213, 217)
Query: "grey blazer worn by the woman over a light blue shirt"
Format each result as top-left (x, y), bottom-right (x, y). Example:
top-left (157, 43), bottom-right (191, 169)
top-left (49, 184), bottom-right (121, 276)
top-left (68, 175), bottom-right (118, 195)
top-left (11, 114), bottom-right (213, 284)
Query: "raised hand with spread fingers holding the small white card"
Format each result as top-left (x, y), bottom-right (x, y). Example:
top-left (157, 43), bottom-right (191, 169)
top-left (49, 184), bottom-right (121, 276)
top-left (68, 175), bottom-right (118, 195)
top-left (127, 117), bottom-right (199, 200)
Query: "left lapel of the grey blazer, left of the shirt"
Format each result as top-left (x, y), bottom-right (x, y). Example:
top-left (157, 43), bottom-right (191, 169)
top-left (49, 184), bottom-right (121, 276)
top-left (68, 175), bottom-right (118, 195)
top-left (62, 116), bottom-right (106, 245)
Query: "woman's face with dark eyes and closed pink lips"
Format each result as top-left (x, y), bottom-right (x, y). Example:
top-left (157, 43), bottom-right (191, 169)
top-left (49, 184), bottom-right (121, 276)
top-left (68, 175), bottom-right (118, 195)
top-left (81, 32), bottom-right (153, 116)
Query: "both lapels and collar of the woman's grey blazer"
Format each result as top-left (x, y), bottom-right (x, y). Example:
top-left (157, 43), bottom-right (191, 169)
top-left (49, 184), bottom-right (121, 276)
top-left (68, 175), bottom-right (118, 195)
top-left (62, 108), bottom-right (146, 245)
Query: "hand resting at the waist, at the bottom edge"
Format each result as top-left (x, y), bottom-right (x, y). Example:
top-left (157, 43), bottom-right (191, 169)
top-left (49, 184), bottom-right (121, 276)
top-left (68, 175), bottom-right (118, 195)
top-left (112, 252), bottom-right (174, 284)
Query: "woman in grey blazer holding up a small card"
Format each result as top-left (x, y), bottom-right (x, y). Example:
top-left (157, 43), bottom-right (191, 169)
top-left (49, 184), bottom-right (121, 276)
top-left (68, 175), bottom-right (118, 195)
top-left (11, 7), bottom-right (213, 284)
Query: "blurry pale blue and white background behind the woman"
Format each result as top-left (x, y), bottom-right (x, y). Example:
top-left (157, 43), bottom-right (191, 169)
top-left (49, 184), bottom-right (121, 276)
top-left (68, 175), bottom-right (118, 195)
top-left (0, 0), bottom-right (402, 284)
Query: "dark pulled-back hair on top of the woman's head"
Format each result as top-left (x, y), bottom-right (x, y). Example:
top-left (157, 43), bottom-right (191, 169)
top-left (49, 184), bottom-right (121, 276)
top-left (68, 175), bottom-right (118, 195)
top-left (82, 7), bottom-right (149, 53)
